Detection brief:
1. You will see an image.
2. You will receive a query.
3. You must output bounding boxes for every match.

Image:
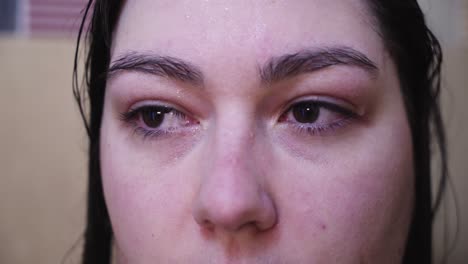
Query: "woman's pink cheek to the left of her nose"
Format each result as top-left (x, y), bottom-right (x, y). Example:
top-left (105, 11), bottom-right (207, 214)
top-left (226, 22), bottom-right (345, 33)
top-left (100, 113), bottom-right (199, 262)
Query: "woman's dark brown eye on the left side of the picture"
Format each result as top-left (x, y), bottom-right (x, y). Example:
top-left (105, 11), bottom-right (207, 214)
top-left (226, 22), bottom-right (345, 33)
top-left (121, 105), bottom-right (198, 138)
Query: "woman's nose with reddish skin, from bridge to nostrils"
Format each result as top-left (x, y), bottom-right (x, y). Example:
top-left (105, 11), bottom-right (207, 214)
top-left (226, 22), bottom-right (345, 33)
top-left (193, 130), bottom-right (277, 234)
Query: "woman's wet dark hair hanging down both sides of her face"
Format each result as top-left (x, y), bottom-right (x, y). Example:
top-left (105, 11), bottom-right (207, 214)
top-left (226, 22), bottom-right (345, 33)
top-left (73, 0), bottom-right (448, 264)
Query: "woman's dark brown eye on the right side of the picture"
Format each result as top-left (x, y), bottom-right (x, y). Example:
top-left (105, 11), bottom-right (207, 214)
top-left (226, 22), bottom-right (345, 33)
top-left (279, 100), bottom-right (357, 134)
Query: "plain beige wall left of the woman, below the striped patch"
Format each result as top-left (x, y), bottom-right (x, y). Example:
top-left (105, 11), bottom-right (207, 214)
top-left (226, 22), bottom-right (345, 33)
top-left (0, 38), bottom-right (86, 263)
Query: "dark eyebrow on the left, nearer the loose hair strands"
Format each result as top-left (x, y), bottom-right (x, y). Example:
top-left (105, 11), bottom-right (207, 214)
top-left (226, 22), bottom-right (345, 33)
top-left (107, 51), bottom-right (203, 85)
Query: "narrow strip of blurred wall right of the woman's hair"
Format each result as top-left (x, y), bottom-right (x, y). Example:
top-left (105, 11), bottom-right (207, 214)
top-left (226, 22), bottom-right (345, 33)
top-left (419, 0), bottom-right (468, 264)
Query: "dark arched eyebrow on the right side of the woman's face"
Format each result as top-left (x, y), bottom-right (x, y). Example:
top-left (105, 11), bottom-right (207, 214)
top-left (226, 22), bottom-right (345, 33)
top-left (260, 46), bottom-right (379, 83)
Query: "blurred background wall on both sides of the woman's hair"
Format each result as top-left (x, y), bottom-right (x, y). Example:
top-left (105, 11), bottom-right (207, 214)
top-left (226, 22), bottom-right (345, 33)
top-left (0, 0), bottom-right (468, 264)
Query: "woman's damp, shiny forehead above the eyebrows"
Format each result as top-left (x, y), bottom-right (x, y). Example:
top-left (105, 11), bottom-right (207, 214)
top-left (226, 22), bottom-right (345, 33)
top-left (112, 0), bottom-right (383, 66)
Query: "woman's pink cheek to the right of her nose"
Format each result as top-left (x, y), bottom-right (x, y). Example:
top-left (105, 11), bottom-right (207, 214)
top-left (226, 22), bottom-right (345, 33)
top-left (274, 109), bottom-right (414, 263)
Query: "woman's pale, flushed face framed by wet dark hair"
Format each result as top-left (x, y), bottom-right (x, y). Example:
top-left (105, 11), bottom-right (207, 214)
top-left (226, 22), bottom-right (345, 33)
top-left (100, 0), bottom-right (414, 263)
